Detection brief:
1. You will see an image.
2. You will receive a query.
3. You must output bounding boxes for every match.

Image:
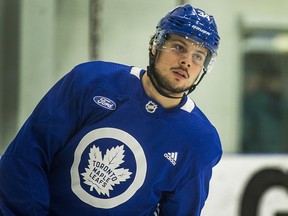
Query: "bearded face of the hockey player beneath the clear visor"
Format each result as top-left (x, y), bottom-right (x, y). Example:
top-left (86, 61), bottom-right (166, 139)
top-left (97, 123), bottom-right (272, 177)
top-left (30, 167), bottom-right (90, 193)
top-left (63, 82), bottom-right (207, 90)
top-left (155, 35), bottom-right (208, 94)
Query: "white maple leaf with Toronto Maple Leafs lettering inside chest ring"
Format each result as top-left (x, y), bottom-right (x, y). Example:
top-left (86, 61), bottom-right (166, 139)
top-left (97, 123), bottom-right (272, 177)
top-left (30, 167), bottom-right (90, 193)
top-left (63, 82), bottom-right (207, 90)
top-left (81, 145), bottom-right (132, 197)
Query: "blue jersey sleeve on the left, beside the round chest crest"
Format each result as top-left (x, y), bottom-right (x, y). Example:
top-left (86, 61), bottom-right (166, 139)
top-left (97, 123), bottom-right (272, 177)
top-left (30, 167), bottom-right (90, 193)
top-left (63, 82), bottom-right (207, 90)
top-left (0, 66), bottom-right (86, 215)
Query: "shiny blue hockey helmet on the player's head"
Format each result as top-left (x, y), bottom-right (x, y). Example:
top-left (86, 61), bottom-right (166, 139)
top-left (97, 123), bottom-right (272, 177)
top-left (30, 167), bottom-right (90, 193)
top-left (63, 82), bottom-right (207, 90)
top-left (153, 4), bottom-right (220, 72)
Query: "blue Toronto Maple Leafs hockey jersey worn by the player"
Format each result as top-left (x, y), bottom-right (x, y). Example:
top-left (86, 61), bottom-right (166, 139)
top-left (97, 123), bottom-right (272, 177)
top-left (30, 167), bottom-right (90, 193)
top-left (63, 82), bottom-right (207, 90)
top-left (0, 61), bottom-right (222, 216)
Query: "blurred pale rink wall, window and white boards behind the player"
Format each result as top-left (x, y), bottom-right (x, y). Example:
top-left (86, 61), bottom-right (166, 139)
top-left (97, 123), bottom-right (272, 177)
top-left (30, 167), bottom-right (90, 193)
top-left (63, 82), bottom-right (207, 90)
top-left (0, 0), bottom-right (288, 216)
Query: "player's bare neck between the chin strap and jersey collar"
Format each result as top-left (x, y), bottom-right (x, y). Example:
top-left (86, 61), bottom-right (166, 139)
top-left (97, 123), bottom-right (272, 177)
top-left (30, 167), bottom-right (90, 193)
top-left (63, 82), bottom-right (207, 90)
top-left (142, 73), bottom-right (181, 109)
